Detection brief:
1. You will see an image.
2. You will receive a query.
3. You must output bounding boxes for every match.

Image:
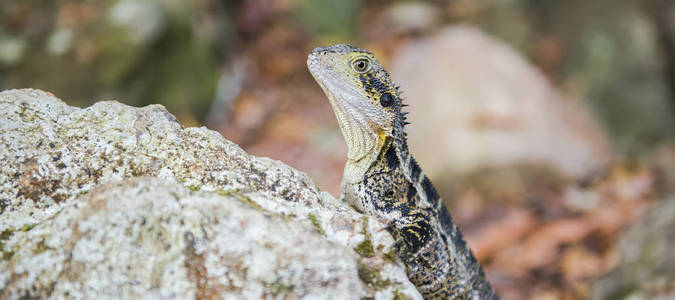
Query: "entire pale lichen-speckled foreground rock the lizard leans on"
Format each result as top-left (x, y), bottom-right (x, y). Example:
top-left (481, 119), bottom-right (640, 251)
top-left (0, 90), bottom-right (421, 299)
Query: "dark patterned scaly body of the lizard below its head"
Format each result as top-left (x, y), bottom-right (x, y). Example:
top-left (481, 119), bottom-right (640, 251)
top-left (343, 119), bottom-right (497, 299)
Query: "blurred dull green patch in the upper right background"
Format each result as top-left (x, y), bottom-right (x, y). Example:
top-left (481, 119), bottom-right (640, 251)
top-left (531, 0), bottom-right (675, 152)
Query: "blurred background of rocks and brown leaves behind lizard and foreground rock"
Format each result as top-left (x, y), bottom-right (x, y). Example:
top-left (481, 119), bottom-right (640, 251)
top-left (0, 0), bottom-right (675, 299)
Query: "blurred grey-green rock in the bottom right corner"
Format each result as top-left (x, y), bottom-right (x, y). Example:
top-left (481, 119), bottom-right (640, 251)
top-left (591, 196), bottom-right (675, 299)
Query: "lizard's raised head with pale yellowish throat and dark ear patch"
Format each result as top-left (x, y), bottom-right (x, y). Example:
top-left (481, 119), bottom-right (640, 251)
top-left (307, 44), bottom-right (401, 162)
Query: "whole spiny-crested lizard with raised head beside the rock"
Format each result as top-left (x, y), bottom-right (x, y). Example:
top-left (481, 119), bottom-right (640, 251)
top-left (307, 44), bottom-right (499, 299)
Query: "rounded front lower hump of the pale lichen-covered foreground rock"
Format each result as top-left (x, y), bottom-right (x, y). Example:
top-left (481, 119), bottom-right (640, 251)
top-left (3, 178), bottom-right (364, 299)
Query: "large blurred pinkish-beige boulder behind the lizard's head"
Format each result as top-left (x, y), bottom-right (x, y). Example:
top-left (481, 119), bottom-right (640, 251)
top-left (391, 26), bottom-right (611, 178)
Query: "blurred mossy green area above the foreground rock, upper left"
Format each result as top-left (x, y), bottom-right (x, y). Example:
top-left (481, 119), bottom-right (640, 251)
top-left (0, 0), bottom-right (228, 118)
